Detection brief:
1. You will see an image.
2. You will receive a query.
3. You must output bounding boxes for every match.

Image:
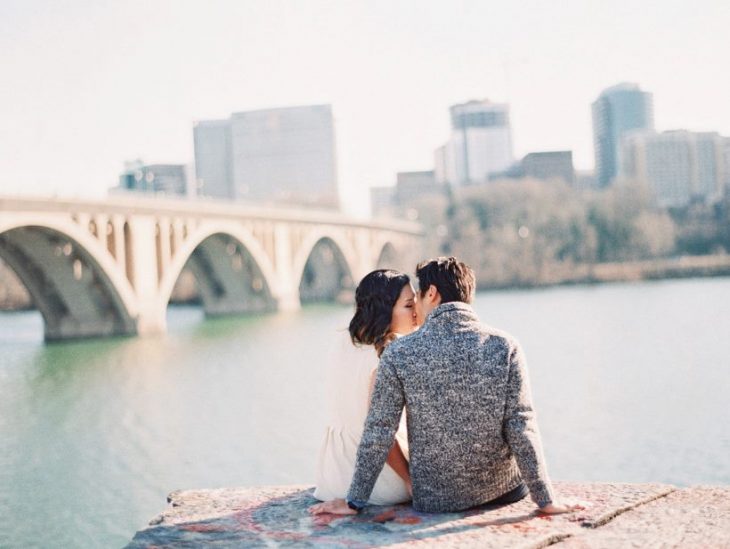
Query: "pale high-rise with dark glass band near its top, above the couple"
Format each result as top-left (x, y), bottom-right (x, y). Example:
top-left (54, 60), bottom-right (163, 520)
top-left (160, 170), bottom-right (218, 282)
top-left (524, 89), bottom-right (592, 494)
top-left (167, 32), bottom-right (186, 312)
top-left (434, 100), bottom-right (513, 185)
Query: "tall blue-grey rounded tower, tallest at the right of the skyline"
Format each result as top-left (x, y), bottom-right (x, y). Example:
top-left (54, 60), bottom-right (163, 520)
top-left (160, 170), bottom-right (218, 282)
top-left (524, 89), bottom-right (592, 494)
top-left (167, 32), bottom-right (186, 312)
top-left (592, 83), bottom-right (654, 187)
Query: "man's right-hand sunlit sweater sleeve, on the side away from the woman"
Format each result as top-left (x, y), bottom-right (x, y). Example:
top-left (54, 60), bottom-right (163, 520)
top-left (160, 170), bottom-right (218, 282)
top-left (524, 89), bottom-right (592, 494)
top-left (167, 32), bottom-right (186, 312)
top-left (503, 343), bottom-right (555, 509)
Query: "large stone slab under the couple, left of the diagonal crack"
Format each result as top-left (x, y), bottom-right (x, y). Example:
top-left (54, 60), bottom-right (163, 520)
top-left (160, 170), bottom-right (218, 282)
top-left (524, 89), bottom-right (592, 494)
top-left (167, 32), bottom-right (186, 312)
top-left (127, 483), bottom-right (675, 549)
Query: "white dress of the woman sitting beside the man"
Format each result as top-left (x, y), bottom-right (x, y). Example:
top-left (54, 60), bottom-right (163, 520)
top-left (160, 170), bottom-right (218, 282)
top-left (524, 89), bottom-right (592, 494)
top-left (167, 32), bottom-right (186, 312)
top-left (314, 332), bottom-right (411, 505)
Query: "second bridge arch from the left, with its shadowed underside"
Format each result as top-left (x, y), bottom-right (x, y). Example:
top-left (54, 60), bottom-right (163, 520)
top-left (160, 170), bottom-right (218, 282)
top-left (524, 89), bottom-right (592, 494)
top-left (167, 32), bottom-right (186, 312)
top-left (159, 223), bottom-right (278, 315)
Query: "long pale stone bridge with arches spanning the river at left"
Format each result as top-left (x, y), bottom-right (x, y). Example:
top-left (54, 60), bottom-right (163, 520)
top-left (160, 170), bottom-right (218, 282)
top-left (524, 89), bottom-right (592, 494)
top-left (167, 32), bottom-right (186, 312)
top-left (0, 197), bottom-right (421, 340)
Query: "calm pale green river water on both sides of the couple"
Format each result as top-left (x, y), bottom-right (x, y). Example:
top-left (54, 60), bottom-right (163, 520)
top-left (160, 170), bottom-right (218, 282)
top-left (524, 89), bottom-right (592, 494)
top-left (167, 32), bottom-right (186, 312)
top-left (0, 278), bottom-right (730, 547)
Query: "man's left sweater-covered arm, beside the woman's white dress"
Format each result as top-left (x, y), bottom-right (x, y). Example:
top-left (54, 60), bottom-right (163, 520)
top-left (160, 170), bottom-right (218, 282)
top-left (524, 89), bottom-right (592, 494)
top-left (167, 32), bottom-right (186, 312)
top-left (347, 351), bottom-right (405, 505)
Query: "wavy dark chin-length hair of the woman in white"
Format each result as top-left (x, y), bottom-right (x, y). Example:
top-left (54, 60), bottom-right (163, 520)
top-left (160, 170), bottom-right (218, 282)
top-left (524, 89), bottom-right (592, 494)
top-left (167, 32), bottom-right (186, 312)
top-left (350, 269), bottom-right (411, 356)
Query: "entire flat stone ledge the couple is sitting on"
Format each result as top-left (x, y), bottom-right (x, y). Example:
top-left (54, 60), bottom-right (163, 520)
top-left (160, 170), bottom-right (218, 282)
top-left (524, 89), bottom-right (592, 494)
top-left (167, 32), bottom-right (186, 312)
top-left (127, 482), bottom-right (730, 549)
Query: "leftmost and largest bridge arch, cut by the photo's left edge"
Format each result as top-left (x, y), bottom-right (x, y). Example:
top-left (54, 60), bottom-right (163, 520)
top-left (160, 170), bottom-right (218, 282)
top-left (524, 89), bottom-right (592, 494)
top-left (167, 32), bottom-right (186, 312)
top-left (0, 220), bottom-right (137, 340)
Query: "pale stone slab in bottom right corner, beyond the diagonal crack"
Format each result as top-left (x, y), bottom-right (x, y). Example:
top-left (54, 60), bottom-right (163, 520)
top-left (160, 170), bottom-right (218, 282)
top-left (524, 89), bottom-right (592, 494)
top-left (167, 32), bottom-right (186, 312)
top-left (557, 486), bottom-right (730, 549)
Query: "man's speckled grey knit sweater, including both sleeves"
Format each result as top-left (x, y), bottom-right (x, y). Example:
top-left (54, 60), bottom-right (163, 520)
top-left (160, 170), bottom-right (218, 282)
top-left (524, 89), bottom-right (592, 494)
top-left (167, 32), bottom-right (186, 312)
top-left (347, 302), bottom-right (553, 512)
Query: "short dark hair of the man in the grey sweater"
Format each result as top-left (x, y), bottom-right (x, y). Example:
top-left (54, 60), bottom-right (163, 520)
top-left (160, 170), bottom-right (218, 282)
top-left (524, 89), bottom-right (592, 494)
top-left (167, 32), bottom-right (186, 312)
top-left (416, 257), bottom-right (476, 303)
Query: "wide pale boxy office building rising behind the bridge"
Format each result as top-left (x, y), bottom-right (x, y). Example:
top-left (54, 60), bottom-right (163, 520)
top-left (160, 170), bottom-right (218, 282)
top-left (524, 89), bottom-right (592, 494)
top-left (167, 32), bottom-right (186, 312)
top-left (194, 105), bottom-right (339, 208)
